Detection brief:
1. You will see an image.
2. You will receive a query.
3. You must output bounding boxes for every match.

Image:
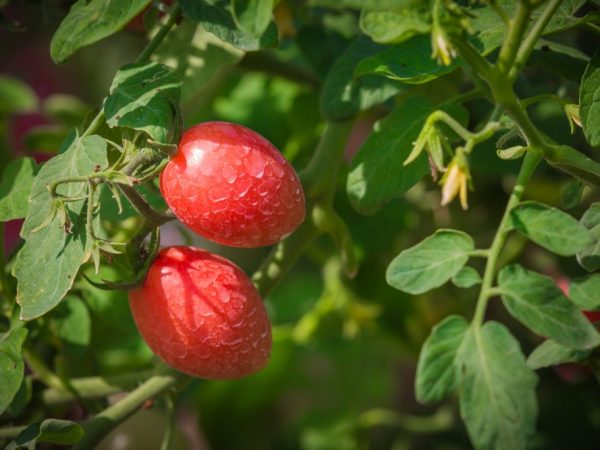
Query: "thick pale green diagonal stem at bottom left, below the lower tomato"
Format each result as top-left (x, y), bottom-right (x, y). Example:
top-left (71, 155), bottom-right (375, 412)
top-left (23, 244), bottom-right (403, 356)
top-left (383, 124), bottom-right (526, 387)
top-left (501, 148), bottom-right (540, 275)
top-left (73, 375), bottom-right (177, 450)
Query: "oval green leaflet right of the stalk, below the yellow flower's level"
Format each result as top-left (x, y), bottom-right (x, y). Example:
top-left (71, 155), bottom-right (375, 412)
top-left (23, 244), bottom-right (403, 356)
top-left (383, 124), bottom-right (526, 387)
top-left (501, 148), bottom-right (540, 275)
top-left (511, 202), bottom-right (593, 256)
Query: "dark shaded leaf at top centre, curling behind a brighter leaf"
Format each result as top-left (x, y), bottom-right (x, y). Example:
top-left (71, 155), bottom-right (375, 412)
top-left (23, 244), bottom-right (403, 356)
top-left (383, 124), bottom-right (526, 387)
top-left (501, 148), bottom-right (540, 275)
top-left (320, 37), bottom-right (406, 120)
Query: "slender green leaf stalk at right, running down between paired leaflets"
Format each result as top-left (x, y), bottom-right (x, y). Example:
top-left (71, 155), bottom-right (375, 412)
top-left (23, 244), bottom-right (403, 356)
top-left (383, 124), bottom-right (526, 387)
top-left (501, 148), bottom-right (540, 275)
top-left (473, 150), bottom-right (542, 327)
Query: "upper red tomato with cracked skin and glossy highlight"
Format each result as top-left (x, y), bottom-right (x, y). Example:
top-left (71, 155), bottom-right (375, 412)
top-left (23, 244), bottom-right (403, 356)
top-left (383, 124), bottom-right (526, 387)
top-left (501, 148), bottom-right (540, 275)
top-left (160, 122), bottom-right (305, 247)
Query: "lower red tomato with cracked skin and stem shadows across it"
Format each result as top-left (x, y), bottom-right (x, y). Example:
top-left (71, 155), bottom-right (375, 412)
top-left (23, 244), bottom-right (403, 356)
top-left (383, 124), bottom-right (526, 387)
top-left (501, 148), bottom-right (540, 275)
top-left (129, 246), bottom-right (271, 380)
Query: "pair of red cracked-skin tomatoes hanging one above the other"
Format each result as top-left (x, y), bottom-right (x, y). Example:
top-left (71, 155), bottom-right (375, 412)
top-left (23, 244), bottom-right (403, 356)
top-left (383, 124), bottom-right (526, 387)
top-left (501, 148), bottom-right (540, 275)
top-left (129, 122), bottom-right (305, 379)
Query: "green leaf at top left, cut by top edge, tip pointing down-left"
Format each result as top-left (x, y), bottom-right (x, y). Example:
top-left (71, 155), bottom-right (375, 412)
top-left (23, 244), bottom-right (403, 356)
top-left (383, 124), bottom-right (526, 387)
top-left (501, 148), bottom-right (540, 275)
top-left (50, 0), bottom-right (150, 63)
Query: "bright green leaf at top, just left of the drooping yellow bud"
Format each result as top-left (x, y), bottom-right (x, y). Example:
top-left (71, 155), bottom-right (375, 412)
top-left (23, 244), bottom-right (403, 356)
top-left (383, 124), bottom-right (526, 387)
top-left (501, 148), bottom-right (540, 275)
top-left (360, 7), bottom-right (431, 44)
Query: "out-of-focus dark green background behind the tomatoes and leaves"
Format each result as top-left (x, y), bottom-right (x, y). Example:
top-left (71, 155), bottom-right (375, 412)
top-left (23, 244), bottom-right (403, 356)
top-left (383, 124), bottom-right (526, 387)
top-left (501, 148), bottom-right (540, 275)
top-left (0, 1), bottom-right (600, 450)
